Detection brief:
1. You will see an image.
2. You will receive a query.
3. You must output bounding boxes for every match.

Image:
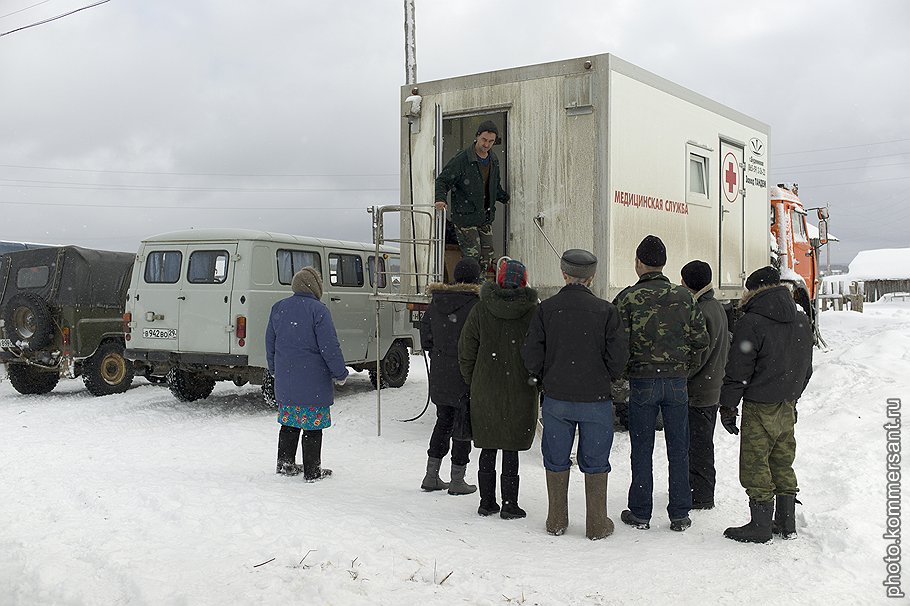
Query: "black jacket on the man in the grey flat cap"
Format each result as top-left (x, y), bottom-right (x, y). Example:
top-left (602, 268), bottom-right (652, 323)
top-left (522, 284), bottom-right (629, 402)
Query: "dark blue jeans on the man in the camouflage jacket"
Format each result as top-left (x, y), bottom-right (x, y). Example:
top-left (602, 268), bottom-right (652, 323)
top-left (629, 377), bottom-right (692, 520)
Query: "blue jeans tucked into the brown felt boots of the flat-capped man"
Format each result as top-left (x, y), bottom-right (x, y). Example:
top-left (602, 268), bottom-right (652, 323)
top-left (540, 396), bottom-right (613, 473)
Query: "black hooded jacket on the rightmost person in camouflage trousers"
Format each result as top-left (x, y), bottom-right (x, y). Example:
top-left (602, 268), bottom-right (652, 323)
top-left (720, 286), bottom-right (814, 408)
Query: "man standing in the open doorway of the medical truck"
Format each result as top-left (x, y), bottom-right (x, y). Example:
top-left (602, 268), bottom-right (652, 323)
top-left (436, 120), bottom-right (509, 272)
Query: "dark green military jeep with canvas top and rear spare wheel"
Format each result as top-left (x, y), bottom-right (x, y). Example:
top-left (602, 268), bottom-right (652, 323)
top-left (0, 246), bottom-right (135, 396)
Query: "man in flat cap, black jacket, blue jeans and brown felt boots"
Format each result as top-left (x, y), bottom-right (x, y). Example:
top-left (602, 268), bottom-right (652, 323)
top-left (521, 249), bottom-right (629, 540)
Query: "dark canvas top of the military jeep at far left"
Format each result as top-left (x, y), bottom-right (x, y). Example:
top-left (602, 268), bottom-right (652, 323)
top-left (0, 246), bottom-right (136, 309)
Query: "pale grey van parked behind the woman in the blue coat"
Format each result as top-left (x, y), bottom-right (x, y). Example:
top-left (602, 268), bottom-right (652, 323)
top-left (124, 229), bottom-right (419, 401)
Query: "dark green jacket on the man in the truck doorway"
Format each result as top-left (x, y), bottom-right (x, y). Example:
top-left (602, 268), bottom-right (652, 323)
top-left (436, 145), bottom-right (509, 227)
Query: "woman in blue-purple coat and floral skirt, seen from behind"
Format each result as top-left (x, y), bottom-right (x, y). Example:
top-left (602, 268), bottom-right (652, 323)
top-left (265, 267), bottom-right (348, 482)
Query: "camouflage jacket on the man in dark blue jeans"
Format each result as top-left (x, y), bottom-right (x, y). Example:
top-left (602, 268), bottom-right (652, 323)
top-left (613, 272), bottom-right (708, 378)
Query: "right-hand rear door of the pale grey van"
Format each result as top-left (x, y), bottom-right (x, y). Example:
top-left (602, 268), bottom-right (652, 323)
top-left (177, 242), bottom-right (237, 354)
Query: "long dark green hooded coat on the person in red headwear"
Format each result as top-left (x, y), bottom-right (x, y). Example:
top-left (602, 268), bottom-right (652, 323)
top-left (458, 282), bottom-right (539, 450)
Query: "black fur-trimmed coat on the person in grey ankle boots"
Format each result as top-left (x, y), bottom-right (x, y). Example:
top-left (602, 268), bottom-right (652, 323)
top-left (420, 284), bottom-right (480, 408)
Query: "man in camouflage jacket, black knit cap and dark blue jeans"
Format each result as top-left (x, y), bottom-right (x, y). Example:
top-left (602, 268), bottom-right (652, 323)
top-left (613, 235), bottom-right (708, 532)
